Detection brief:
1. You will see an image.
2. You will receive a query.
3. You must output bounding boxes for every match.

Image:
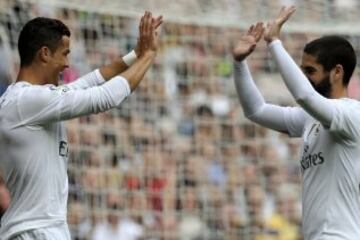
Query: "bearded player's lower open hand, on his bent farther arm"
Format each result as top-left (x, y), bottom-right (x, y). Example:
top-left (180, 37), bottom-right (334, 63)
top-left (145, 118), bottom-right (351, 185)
top-left (233, 22), bottom-right (264, 61)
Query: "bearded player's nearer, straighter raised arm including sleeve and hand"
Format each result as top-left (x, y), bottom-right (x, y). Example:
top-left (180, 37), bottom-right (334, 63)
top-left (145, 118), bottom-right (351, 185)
top-left (264, 7), bottom-right (333, 127)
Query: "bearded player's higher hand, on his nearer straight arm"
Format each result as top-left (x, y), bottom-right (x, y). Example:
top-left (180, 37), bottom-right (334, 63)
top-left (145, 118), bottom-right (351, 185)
top-left (264, 6), bottom-right (296, 43)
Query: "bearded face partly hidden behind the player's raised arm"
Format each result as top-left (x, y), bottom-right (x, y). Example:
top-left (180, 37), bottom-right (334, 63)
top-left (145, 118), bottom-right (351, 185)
top-left (301, 53), bottom-right (331, 98)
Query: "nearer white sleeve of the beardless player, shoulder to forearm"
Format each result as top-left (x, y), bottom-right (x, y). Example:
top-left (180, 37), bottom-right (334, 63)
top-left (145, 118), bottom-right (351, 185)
top-left (17, 76), bottom-right (131, 126)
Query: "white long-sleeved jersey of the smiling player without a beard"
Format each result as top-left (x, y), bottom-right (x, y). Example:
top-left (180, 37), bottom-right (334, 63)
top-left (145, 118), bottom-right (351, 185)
top-left (0, 70), bottom-right (130, 240)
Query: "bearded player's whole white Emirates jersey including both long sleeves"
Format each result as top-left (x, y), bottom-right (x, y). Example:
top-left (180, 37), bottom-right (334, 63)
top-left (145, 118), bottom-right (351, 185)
top-left (234, 40), bottom-right (360, 240)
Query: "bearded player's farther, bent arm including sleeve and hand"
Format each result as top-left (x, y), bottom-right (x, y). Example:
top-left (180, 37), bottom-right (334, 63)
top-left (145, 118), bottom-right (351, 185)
top-left (233, 23), bottom-right (305, 137)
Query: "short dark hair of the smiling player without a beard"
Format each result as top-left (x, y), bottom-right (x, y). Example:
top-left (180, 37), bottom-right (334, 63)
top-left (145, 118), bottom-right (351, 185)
top-left (18, 17), bottom-right (70, 67)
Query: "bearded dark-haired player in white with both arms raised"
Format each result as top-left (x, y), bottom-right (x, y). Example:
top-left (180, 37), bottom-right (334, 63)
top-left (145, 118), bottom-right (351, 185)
top-left (233, 7), bottom-right (360, 240)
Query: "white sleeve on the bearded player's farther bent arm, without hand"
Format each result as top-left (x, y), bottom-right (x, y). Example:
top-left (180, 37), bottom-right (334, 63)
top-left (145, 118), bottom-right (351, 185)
top-left (234, 62), bottom-right (306, 137)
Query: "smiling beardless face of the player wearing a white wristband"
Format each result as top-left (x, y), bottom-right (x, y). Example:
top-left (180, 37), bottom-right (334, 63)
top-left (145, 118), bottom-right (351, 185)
top-left (49, 36), bottom-right (70, 85)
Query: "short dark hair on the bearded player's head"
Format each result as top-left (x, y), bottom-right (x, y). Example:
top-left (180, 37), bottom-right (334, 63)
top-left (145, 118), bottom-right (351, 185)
top-left (304, 36), bottom-right (356, 86)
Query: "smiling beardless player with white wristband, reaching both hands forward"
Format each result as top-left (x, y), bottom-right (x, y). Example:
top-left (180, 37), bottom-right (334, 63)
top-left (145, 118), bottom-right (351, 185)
top-left (0, 12), bottom-right (162, 240)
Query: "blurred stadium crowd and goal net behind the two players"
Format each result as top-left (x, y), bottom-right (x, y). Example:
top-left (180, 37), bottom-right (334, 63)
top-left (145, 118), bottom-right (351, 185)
top-left (0, 0), bottom-right (360, 240)
